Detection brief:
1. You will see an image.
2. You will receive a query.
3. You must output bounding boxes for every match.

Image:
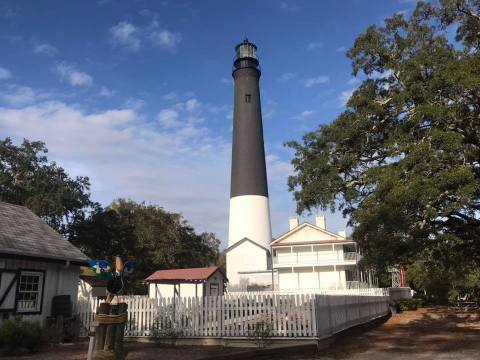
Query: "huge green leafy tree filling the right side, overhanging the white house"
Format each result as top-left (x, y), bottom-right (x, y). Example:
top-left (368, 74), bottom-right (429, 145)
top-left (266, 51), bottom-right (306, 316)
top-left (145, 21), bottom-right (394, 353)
top-left (287, 0), bottom-right (480, 268)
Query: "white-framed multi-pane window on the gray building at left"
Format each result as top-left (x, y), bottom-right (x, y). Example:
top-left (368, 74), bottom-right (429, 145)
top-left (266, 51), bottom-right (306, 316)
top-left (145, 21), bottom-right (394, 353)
top-left (17, 271), bottom-right (44, 312)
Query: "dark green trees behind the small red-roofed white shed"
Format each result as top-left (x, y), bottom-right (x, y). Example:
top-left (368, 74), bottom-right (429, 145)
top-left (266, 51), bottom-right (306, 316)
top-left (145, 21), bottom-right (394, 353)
top-left (71, 199), bottom-right (220, 286)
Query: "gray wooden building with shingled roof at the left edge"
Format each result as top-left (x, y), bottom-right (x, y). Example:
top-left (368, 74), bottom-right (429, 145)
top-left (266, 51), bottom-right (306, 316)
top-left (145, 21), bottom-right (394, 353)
top-left (0, 202), bottom-right (87, 325)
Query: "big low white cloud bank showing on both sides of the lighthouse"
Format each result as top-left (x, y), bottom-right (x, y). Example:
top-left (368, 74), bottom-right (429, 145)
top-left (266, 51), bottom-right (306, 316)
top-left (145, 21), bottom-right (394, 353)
top-left (0, 87), bottom-right (312, 246)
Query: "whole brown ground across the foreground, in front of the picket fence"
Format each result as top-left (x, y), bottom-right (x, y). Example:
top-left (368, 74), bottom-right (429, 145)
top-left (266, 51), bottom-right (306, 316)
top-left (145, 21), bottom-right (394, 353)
top-left (0, 308), bottom-right (480, 360)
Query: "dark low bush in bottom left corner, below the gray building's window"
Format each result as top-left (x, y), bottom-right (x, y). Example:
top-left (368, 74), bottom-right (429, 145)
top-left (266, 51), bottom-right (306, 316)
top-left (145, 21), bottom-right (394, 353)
top-left (0, 317), bottom-right (46, 355)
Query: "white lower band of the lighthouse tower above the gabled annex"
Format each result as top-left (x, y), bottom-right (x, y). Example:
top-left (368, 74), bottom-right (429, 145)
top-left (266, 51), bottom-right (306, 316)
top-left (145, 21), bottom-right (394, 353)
top-left (228, 195), bottom-right (272, 249)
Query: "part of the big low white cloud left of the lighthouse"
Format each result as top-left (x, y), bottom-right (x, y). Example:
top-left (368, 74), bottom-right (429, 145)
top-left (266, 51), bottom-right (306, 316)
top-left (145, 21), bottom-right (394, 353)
top-left (0, 102), bottom-right (230, 245)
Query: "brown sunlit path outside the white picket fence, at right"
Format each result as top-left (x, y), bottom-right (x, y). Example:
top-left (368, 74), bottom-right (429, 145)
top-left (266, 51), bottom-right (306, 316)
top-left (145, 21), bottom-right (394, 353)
top-left (272, 308), bottom-right (480, 360)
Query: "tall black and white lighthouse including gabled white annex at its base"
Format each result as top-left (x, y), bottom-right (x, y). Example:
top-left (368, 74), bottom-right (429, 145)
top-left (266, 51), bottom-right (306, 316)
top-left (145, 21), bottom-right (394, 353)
top-left (226, 39), bottom-right (272, 290)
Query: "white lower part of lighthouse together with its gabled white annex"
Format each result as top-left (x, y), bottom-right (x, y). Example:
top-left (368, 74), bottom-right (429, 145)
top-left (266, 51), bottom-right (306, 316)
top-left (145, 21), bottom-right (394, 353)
top-left (226, 195), bottom-right (272, 291)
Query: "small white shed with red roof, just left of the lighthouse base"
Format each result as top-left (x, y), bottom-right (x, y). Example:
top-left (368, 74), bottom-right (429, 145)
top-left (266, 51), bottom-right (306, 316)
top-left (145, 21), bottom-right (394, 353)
top-left (145, 266), bottom-right (228, 298)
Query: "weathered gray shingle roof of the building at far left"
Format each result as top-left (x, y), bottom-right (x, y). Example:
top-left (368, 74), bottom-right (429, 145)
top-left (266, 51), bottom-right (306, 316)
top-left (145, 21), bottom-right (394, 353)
top-left (0, 201), bottom-right (87, 263)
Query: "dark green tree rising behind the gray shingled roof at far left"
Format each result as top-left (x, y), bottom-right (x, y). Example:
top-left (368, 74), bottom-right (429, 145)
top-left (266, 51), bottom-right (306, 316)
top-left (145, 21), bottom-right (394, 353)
top-left (0, 138), bottom-right (93, 235)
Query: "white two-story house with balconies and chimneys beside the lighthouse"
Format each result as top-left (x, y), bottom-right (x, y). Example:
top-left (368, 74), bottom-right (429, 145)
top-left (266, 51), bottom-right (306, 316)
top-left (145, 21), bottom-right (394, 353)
top-left (271, 215), bottom-right (378, 291)
